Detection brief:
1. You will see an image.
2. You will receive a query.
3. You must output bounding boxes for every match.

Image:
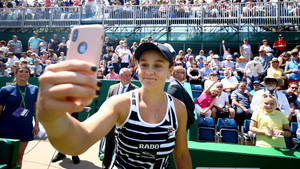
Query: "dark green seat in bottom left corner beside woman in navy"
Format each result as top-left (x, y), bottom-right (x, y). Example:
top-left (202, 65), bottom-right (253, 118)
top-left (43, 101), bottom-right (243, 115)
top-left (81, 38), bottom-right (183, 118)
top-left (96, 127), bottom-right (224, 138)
top-left (0, 138), bottom-right (20, 169)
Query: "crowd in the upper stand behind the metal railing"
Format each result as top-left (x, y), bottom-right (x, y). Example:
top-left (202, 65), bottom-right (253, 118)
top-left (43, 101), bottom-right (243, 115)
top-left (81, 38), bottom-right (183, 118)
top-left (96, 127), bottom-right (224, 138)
top-left (0, 0), bottom-right (300, 20)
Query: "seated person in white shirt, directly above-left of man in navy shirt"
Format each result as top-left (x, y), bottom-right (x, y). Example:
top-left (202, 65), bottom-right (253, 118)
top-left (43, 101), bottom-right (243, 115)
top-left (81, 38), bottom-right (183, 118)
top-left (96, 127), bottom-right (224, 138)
top-left (221, 70), bottom-right (239, 96)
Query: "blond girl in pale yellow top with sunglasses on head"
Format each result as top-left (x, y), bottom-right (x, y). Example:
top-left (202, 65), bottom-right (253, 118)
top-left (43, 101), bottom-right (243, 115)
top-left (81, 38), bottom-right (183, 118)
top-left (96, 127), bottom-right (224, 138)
top-left (250, 92), bottom-right (291, 148)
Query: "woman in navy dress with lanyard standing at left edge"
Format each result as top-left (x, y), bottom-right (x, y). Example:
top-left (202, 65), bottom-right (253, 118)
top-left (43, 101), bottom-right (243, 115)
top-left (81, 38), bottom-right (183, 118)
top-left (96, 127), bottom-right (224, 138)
top-left (0, 66), bottom-right (39, 167)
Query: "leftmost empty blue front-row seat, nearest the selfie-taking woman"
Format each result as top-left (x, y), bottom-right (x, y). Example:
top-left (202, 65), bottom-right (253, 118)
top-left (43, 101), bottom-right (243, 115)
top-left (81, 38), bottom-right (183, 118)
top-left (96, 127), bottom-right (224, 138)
top-left (198, 117), bottom-right (215, 142)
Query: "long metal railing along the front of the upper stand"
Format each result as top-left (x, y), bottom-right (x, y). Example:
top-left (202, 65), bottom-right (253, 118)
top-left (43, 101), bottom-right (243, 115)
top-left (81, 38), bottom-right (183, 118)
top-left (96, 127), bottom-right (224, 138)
top-left (0, 2), bottom-right (300, 30)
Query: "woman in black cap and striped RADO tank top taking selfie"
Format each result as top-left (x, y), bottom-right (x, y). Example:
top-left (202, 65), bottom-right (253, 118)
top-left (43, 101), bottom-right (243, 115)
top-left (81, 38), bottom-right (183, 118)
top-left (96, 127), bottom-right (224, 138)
top-left (37, 43), bottom-right (192, 169)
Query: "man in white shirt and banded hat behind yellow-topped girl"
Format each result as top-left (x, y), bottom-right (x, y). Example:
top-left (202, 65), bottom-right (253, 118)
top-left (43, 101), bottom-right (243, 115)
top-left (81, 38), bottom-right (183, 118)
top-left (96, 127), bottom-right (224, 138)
top-left (250, 76), bottom-right (291, 117)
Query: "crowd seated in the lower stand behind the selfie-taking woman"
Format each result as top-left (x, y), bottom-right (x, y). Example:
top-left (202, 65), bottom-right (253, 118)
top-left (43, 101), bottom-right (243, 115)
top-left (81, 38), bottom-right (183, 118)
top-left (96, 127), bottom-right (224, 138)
top-left (0, 33), bottom-right (300, 148)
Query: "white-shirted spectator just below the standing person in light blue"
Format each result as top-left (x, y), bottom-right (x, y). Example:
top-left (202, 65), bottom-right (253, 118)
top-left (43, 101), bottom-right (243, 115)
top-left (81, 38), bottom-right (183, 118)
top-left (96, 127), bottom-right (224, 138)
top-left (244, 57), bottom-right (263, 87)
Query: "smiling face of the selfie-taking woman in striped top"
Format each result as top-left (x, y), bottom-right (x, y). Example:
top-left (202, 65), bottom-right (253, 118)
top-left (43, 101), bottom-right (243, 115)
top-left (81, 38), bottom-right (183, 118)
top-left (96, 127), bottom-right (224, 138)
top-left (138, 50), bottom-right (173, 87)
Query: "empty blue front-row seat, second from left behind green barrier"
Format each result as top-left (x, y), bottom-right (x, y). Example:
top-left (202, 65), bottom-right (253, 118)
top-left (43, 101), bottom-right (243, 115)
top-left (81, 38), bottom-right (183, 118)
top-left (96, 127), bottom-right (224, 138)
top-left (217, 118), bottom-right (239, 144)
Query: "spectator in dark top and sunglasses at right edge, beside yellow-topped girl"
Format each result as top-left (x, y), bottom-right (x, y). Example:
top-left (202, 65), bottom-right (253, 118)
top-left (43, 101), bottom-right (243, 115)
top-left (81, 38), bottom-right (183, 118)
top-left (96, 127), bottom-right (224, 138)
top-left (282, 82), bottom-right (299, 122)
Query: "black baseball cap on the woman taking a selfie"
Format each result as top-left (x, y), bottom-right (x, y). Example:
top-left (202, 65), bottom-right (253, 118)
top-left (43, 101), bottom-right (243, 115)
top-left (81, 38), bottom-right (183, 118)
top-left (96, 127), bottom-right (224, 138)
top-left (134, 43), bottom-right (173, 65)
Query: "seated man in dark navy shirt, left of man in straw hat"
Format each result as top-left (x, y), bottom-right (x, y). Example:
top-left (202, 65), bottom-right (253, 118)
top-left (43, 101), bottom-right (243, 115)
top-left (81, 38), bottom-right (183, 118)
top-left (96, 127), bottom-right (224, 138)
top-left (231, 81), bottom-right (252, 126)
